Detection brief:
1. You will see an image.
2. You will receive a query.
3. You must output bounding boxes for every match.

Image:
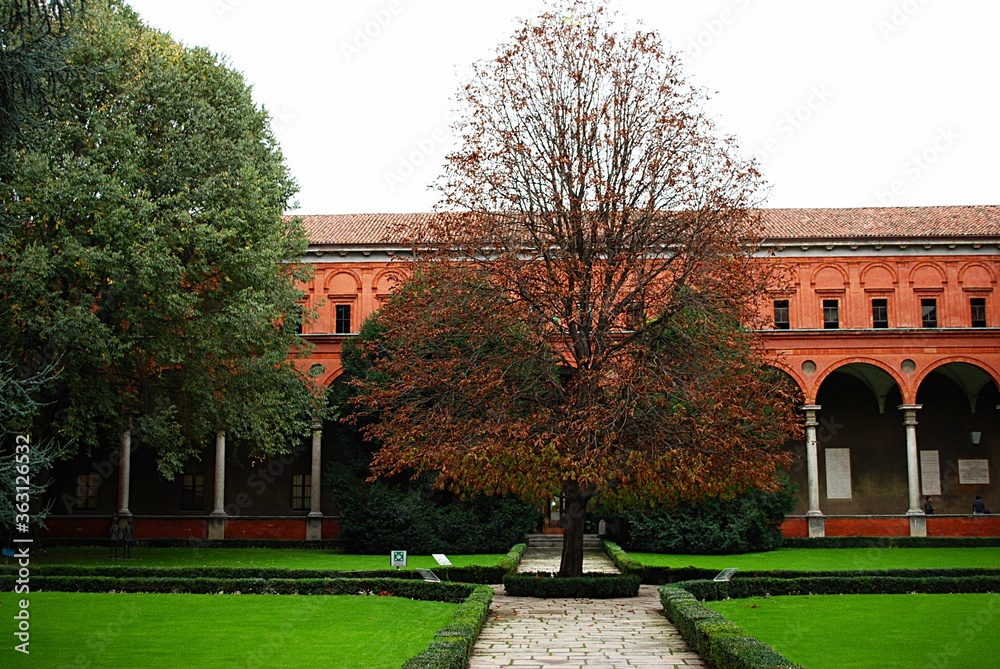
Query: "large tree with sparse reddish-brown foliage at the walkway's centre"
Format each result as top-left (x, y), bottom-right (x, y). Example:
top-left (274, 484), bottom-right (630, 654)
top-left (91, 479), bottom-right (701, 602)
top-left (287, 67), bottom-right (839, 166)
top-left (348, 0), bottom-right (796, 576)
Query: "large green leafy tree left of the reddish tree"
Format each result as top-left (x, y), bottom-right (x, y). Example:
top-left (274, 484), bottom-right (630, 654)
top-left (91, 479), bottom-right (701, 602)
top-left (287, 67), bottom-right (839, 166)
top-left (0, 0), bottom-right (321, 476)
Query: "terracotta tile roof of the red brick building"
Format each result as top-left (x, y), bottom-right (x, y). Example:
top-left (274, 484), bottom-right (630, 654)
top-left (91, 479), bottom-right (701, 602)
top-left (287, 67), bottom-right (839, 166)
top-left (290, 206), bottom-right (1000, 246)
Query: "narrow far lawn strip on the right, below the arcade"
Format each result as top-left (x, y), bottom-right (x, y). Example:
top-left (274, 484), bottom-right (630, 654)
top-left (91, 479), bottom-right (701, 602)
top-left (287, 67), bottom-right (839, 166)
top-left (628, 548), bottom-right (1000, 571)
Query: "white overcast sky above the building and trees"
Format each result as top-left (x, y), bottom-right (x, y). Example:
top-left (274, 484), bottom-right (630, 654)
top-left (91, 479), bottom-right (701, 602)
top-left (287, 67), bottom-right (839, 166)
top-left (121, 0), bottom-right (1000, 214)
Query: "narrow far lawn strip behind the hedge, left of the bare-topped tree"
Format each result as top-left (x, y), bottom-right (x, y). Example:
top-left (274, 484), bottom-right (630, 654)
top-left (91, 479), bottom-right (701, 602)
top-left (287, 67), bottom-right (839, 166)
top-left (26, 547), bottom-right (504, 571)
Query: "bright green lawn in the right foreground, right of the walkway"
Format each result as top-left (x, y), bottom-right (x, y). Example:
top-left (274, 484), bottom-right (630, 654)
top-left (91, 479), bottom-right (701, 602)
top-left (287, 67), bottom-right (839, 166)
top-left (706, 594), bottom-right (1000, 669)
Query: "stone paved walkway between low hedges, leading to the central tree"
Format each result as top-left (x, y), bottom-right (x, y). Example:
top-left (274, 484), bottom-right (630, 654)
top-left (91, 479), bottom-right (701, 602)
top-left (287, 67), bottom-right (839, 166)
top-left (469, 548), bottom-right (706, 669)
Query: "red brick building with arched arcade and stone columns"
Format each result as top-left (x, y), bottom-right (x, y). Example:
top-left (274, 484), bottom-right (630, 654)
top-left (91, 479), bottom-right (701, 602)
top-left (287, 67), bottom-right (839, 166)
top-left (39, 207), bottom-right (1000, 539)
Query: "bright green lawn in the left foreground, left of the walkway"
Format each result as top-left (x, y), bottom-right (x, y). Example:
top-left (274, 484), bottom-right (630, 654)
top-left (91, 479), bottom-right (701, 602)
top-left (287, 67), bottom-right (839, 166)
top-left (0, 592), bottom-right (457, 669)
